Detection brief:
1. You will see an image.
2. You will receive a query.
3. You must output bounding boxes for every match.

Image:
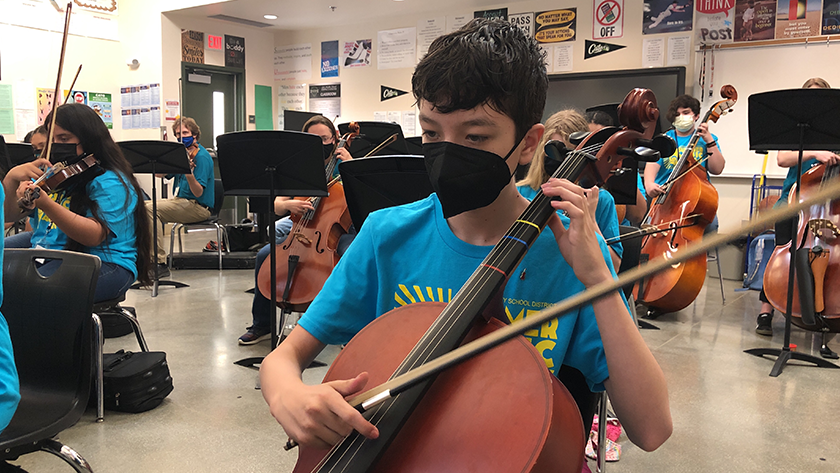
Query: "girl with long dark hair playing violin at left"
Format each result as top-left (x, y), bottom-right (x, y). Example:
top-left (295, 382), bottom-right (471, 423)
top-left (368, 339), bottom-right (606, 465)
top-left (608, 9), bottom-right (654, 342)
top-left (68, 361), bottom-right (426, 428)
top-left (3, 103), bottom-right (152, 302)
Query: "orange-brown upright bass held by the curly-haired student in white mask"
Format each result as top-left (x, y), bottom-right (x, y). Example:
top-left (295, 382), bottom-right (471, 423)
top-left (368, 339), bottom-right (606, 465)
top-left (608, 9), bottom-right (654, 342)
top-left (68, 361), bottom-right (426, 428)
top-left (633, 85), bottom-right (738, 316)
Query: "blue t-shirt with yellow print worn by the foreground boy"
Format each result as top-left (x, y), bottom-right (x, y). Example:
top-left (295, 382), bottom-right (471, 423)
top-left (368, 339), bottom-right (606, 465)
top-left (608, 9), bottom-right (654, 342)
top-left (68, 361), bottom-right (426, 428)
top-left (299, 194), bottom-right (612, 391)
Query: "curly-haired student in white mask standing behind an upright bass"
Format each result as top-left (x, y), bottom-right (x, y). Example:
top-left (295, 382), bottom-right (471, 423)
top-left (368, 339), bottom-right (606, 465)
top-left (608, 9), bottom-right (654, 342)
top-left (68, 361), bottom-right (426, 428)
top-left (645, 95), bottom-right (726, 233)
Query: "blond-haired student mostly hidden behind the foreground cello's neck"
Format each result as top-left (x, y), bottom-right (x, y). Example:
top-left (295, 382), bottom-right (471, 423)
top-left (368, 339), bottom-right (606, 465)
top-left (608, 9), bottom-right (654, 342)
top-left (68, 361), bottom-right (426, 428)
top-left (516, 109), bottom-right (624, 268)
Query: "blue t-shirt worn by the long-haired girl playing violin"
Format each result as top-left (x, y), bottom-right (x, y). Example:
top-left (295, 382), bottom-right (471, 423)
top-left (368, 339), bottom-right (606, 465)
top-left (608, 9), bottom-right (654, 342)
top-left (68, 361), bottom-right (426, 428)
top-left (30, 170), bottom-right (138, 278)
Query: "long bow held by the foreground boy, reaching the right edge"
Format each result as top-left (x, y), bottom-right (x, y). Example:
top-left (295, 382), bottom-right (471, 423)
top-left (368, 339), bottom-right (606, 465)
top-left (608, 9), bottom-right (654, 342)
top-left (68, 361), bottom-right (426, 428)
top-left (342, 181), bottom-right (840, 412)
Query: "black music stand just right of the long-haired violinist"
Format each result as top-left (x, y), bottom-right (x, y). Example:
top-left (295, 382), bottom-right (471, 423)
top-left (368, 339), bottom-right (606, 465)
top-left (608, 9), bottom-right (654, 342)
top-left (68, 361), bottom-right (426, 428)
top-left (117, 140), bottom-right (192, 297)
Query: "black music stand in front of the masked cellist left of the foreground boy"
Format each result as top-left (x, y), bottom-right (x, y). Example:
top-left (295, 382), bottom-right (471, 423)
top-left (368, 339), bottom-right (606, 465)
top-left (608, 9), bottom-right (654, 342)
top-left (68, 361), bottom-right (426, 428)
top-left (216, 131), bottom-right (329, 368)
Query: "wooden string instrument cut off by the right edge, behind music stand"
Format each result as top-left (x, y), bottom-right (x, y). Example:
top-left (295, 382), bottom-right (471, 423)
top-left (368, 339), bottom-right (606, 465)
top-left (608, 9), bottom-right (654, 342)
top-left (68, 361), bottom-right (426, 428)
top-left (764, 164), bottom-right (840, 333)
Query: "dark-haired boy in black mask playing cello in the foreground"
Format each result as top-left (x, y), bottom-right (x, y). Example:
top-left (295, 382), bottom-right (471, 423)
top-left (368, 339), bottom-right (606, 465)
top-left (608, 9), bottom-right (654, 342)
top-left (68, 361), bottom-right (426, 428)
top-left (260, 19), bottom-right (672, 450)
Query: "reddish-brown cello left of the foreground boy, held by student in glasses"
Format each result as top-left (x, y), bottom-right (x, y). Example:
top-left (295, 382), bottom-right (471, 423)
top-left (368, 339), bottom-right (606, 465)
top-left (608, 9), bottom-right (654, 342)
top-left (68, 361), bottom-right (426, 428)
top-left (257, 122), bottom-right (359, 312)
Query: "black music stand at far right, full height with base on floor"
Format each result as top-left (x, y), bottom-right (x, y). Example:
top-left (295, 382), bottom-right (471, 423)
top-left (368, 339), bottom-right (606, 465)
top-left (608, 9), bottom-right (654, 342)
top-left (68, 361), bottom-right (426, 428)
top-left (744, 89), bottom-right (840, 377)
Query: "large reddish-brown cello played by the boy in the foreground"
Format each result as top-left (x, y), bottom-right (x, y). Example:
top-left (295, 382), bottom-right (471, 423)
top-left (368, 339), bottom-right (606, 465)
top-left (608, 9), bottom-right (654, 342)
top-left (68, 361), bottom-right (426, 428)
top-left (295, 89), bottom-right (658, 473)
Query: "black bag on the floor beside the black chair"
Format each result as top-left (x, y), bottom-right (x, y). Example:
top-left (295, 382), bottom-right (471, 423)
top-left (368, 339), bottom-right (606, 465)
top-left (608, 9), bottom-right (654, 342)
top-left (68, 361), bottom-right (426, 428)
top-left (103, 350), bottom-right (173, 412)
